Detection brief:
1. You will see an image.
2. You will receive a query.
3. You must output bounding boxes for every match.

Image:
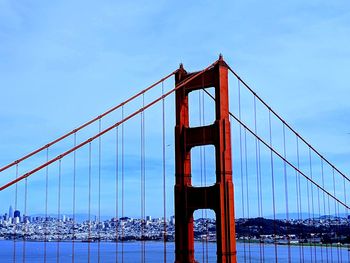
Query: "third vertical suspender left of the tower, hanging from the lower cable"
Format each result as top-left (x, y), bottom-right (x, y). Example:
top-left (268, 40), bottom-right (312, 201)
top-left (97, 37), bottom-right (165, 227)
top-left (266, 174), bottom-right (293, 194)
top-left (115, 126), bottom-right (119, 263)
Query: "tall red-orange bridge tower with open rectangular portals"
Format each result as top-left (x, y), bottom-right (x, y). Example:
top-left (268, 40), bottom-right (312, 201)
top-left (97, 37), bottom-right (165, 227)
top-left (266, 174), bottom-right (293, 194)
top-left (175, 56), bottom-right (236, 263)
